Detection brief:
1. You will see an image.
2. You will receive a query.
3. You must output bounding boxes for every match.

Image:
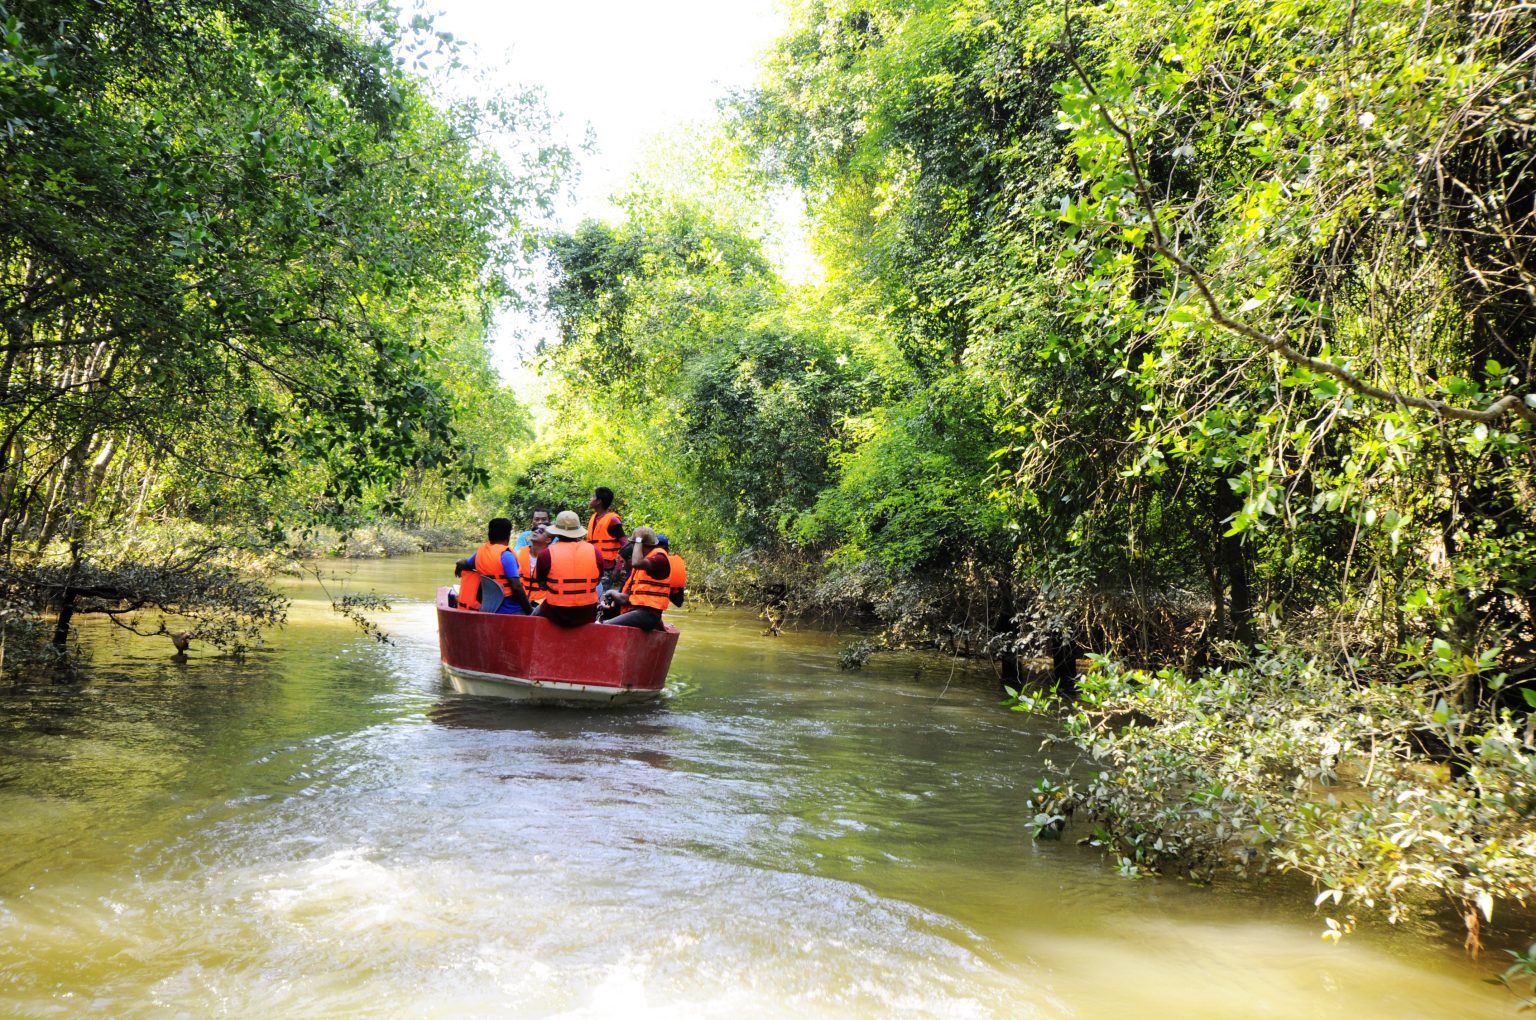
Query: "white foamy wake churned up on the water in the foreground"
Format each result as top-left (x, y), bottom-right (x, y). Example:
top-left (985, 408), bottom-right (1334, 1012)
top-left (72, 846), bottom-right (1054, 1018)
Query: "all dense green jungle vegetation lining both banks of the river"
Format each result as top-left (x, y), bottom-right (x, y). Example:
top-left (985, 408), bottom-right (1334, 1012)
top-left (0, 0), bottom-right (1536, 975)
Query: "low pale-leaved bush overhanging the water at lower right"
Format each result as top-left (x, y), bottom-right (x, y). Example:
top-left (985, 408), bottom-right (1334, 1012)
top-left (1018, 651), bottom-right (1536, 937)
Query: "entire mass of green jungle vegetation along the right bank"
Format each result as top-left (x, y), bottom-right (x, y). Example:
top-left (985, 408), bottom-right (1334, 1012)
top-left (511, 0), bottom-right (1536, 958)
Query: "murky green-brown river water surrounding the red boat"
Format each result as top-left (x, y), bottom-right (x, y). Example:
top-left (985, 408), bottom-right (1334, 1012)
top-left (0, 556), bottom-right (1516, 1020)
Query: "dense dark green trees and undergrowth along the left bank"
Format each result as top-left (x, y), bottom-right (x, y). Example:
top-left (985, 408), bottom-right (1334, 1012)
top-left (0, 0), bottom-right (552, 654)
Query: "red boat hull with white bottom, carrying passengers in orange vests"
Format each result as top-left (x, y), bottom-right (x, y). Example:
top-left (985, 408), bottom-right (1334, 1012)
top-left (438, 587), bottom-right (677, 704)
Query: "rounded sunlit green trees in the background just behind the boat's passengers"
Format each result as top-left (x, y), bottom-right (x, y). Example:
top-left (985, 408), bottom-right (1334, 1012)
top-left (531, 178), bottom-right (868, 551)
